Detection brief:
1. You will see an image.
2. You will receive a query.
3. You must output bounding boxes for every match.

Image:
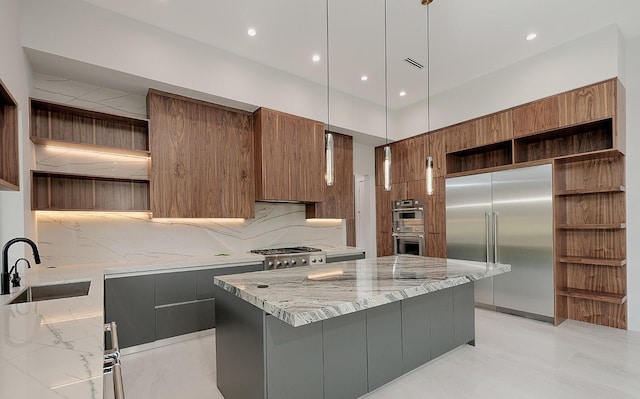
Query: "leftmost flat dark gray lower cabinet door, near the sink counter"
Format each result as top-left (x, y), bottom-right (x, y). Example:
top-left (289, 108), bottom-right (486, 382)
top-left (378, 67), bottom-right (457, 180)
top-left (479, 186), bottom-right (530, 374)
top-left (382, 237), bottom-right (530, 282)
top-left (104, 276), bottom-right (156, 348)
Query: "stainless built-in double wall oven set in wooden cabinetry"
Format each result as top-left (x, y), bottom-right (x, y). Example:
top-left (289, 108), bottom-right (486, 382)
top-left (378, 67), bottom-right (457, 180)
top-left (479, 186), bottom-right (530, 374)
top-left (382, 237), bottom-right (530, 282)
top-left (392, 199), bottom-right (426, 256)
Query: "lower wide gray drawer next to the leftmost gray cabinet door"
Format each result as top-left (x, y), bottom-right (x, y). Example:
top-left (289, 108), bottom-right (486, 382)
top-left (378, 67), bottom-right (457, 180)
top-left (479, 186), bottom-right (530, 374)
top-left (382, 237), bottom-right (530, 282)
top-left (156, 302), bottom-right (198, 339)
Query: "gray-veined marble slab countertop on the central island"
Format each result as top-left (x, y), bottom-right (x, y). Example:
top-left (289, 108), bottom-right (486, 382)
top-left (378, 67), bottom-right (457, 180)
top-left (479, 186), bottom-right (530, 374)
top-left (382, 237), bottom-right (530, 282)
top-left (214, 255), bottom-right (511, 327)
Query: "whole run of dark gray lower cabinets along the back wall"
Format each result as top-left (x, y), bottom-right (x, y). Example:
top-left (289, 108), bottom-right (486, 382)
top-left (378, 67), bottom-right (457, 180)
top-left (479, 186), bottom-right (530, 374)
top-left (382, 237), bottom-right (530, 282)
top-left (104, 263), bottom-right (263, 348)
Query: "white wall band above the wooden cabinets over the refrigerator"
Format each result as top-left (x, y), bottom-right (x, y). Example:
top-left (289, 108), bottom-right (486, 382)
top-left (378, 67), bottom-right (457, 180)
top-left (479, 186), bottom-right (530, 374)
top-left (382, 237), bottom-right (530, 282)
top-left (394, 26), bottom-right (624, 139)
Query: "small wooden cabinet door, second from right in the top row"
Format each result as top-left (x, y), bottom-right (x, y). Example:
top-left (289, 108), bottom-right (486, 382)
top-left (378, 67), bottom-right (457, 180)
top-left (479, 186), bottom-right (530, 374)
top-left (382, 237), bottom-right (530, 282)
top-left (513, 96), bottom-right (560, 137)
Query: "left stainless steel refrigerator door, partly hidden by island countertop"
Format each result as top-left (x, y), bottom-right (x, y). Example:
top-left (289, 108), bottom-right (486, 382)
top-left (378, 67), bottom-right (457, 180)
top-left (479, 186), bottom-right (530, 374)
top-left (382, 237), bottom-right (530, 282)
top-left (446, 173), bottom-right (493, 305)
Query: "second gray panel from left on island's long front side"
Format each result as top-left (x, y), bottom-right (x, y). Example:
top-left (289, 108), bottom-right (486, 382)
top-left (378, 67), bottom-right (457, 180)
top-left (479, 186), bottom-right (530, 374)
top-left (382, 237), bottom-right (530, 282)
top-left (322, 311), bottom-right (368, 399)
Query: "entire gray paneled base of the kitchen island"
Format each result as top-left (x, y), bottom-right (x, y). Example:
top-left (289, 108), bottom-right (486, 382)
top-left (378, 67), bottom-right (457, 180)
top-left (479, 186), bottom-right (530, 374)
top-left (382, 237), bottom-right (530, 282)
top-left (214, 268), bottom-right (484, 399)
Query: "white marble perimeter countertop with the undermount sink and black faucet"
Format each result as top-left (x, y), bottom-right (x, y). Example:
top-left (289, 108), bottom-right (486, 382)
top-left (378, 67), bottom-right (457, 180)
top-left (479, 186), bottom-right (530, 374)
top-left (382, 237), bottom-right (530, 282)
top-left (0, 247), bottom-right (360, 399)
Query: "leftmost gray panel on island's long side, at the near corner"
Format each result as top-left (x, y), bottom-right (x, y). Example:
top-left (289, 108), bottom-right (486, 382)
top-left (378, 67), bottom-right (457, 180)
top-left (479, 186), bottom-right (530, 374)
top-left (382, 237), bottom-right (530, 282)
top-left (265, 315), bottom-right (324, 399)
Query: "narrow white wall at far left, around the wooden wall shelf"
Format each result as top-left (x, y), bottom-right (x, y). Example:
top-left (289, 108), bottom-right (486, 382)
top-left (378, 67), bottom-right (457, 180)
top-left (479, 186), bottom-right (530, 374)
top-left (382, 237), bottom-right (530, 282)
top-left (0, 0), bottom-right (35, 250)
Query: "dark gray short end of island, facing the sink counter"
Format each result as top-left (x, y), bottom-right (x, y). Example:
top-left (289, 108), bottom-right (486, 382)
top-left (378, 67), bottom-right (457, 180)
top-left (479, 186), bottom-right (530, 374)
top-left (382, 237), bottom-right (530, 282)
top-left (214, 286), bottom-right (266, 399)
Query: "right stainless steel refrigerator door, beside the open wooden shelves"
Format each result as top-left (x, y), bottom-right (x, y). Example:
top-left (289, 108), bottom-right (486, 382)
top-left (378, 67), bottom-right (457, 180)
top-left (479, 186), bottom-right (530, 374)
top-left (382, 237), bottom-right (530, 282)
top-left (492, 165), bottom-right (554, 317)
